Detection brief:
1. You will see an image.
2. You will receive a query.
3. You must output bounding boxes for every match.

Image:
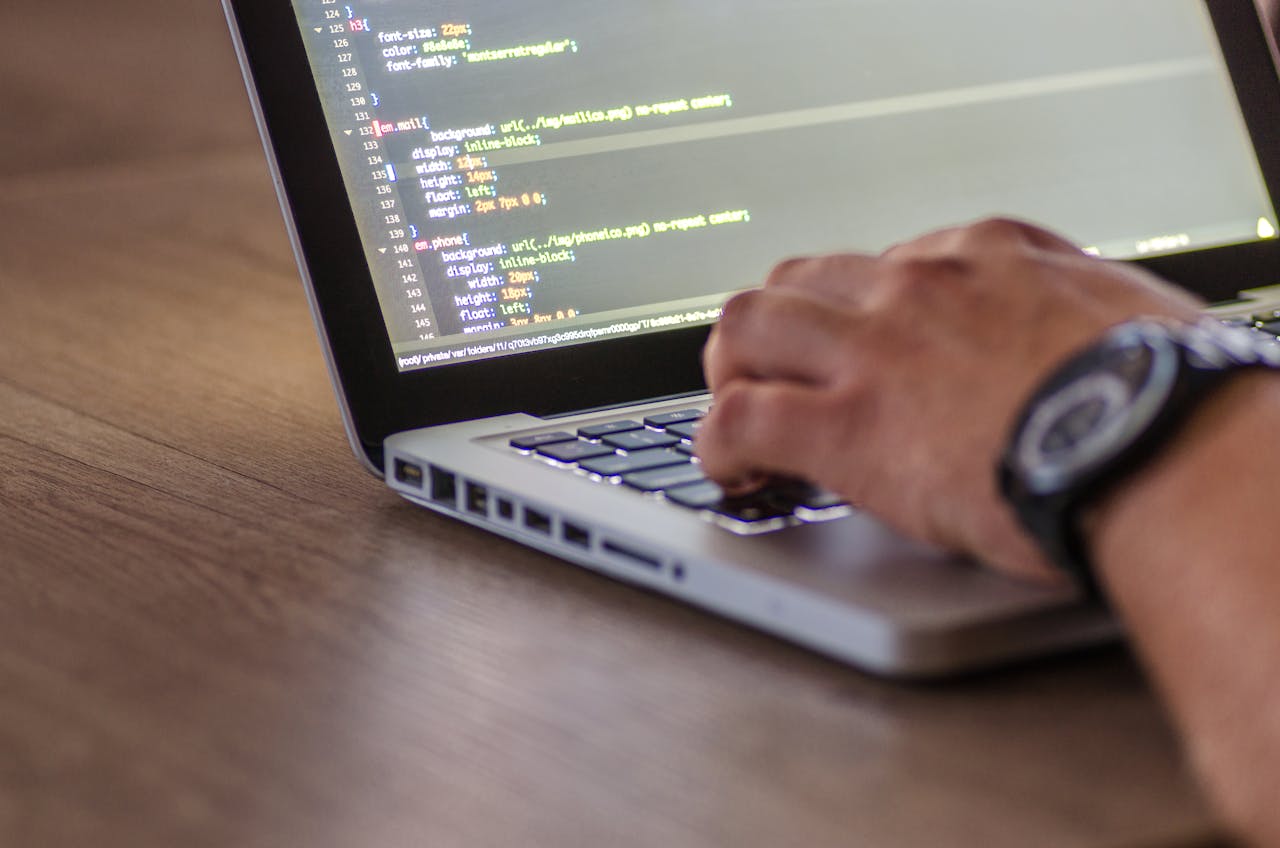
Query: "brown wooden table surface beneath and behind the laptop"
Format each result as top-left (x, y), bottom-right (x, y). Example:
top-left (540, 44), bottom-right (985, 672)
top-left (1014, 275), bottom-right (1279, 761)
top-left (0, 0), bottom-right (1228, 847)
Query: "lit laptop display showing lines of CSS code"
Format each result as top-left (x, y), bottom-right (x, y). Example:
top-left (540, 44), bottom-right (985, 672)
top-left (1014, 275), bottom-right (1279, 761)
top-left (293, 0), bottom-right (1276, 371)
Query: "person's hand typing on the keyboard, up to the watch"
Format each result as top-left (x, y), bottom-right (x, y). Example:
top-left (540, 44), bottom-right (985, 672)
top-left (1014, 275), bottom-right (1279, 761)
top-left (696, 220), bottom-right (1198, 580)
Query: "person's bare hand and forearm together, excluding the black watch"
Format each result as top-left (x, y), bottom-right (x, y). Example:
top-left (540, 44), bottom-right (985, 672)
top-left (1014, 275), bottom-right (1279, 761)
top-left (698, 220), bottom-right (1280, 845)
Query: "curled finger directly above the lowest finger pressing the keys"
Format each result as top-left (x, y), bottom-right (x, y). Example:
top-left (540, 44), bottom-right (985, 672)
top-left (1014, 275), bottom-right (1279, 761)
top-left (703, 289), bottom-right (856, 392)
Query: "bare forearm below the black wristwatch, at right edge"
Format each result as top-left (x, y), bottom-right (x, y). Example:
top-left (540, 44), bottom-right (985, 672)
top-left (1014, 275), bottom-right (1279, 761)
top-left (1093, 374), bottom-right (1280, 844)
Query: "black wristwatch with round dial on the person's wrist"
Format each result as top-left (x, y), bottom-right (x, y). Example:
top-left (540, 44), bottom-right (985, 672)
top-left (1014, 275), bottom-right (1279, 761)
top-left (998, 318), bottom-right (1280, 599)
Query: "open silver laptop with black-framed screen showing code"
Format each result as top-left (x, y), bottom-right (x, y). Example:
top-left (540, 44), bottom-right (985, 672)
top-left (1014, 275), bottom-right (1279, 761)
top-left (224, 0), bottom-right (1280, 678)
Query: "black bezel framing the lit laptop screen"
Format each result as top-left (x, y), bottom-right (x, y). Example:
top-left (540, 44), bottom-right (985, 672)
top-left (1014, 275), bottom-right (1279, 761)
top-left (224, 0), bottom-right (1280, 468)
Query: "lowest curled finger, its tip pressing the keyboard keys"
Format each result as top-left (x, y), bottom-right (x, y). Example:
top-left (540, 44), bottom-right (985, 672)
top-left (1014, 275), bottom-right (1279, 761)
top-left (695, 379), bottom-right (837, 488)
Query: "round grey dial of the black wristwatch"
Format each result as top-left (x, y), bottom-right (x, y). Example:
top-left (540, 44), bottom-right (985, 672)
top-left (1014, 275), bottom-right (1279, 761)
top-left (1014, 326), bottom-right (1178, 494)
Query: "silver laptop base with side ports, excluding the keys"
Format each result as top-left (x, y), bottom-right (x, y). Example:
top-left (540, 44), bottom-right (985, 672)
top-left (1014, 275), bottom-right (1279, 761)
top-left (387, 401), bottom-right (1119, 679)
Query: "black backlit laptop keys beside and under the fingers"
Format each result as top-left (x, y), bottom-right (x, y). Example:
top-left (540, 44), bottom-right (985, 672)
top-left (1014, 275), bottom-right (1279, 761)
top-left (511, 409), bottom-right (852, 534)
